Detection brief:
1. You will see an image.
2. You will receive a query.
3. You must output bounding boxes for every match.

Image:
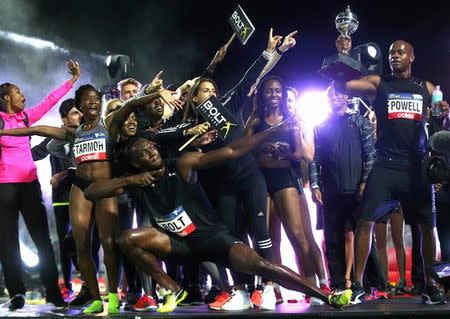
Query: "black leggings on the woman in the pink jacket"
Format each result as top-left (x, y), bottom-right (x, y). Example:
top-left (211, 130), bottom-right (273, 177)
top-left (0, 180), bottom-right (59, 298)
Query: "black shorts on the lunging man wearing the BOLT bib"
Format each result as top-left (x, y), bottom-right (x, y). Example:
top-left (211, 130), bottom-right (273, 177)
top-left (163, 225), bottom-right (242, 266)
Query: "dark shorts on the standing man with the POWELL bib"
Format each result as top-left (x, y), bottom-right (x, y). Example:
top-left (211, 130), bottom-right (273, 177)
top-left (360, 162), bottom-right (434, 227)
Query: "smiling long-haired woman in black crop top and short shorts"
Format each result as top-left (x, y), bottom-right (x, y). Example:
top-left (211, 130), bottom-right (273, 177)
top-left (245, 77), bottom-right (326, 292)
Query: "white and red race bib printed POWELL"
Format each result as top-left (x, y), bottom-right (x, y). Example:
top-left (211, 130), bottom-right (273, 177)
top-left (387, 93), bottom-right (423, 121)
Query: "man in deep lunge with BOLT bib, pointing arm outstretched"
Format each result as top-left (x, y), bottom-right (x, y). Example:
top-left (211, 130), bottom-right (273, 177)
top-left (85, 119), bottom-right (351, 312)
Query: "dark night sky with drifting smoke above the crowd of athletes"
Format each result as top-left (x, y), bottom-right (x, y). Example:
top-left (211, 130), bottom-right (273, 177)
top-left (0, 0), bottom-right (450, 102)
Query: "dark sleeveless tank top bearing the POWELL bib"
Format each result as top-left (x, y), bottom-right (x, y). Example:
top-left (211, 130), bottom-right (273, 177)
top-left (374, 75), bottom-right (431, 165)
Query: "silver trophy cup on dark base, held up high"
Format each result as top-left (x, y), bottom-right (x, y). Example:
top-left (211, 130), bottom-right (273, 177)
top-left (319, 6), bottom-right (366, 82)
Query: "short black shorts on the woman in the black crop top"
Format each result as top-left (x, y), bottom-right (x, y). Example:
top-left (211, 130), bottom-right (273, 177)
top-left (262, 167), bottom-right (301, 195)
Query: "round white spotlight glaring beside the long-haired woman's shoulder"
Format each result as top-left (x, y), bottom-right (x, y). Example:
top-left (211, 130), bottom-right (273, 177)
top-left (296, 91), bottom-right (331, 127)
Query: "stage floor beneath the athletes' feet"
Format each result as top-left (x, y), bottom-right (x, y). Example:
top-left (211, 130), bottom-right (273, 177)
top-left (0, 297), bottom-right (450, 319)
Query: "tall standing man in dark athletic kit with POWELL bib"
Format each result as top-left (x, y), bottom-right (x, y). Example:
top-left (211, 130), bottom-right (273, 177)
top-left (336, 39), bottom-right (449, 304)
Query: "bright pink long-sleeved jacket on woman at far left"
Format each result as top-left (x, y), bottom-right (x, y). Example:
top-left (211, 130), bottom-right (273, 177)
top-left (0, 81), bottom-right (73, 184)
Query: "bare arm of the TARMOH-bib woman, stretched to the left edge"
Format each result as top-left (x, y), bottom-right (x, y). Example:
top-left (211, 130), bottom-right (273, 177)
top-left (0, 125), bottom-right (75, 141)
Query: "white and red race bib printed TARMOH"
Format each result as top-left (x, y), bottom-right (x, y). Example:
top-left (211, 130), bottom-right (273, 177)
top-left (73, 133), bottom-right (107, 164)
